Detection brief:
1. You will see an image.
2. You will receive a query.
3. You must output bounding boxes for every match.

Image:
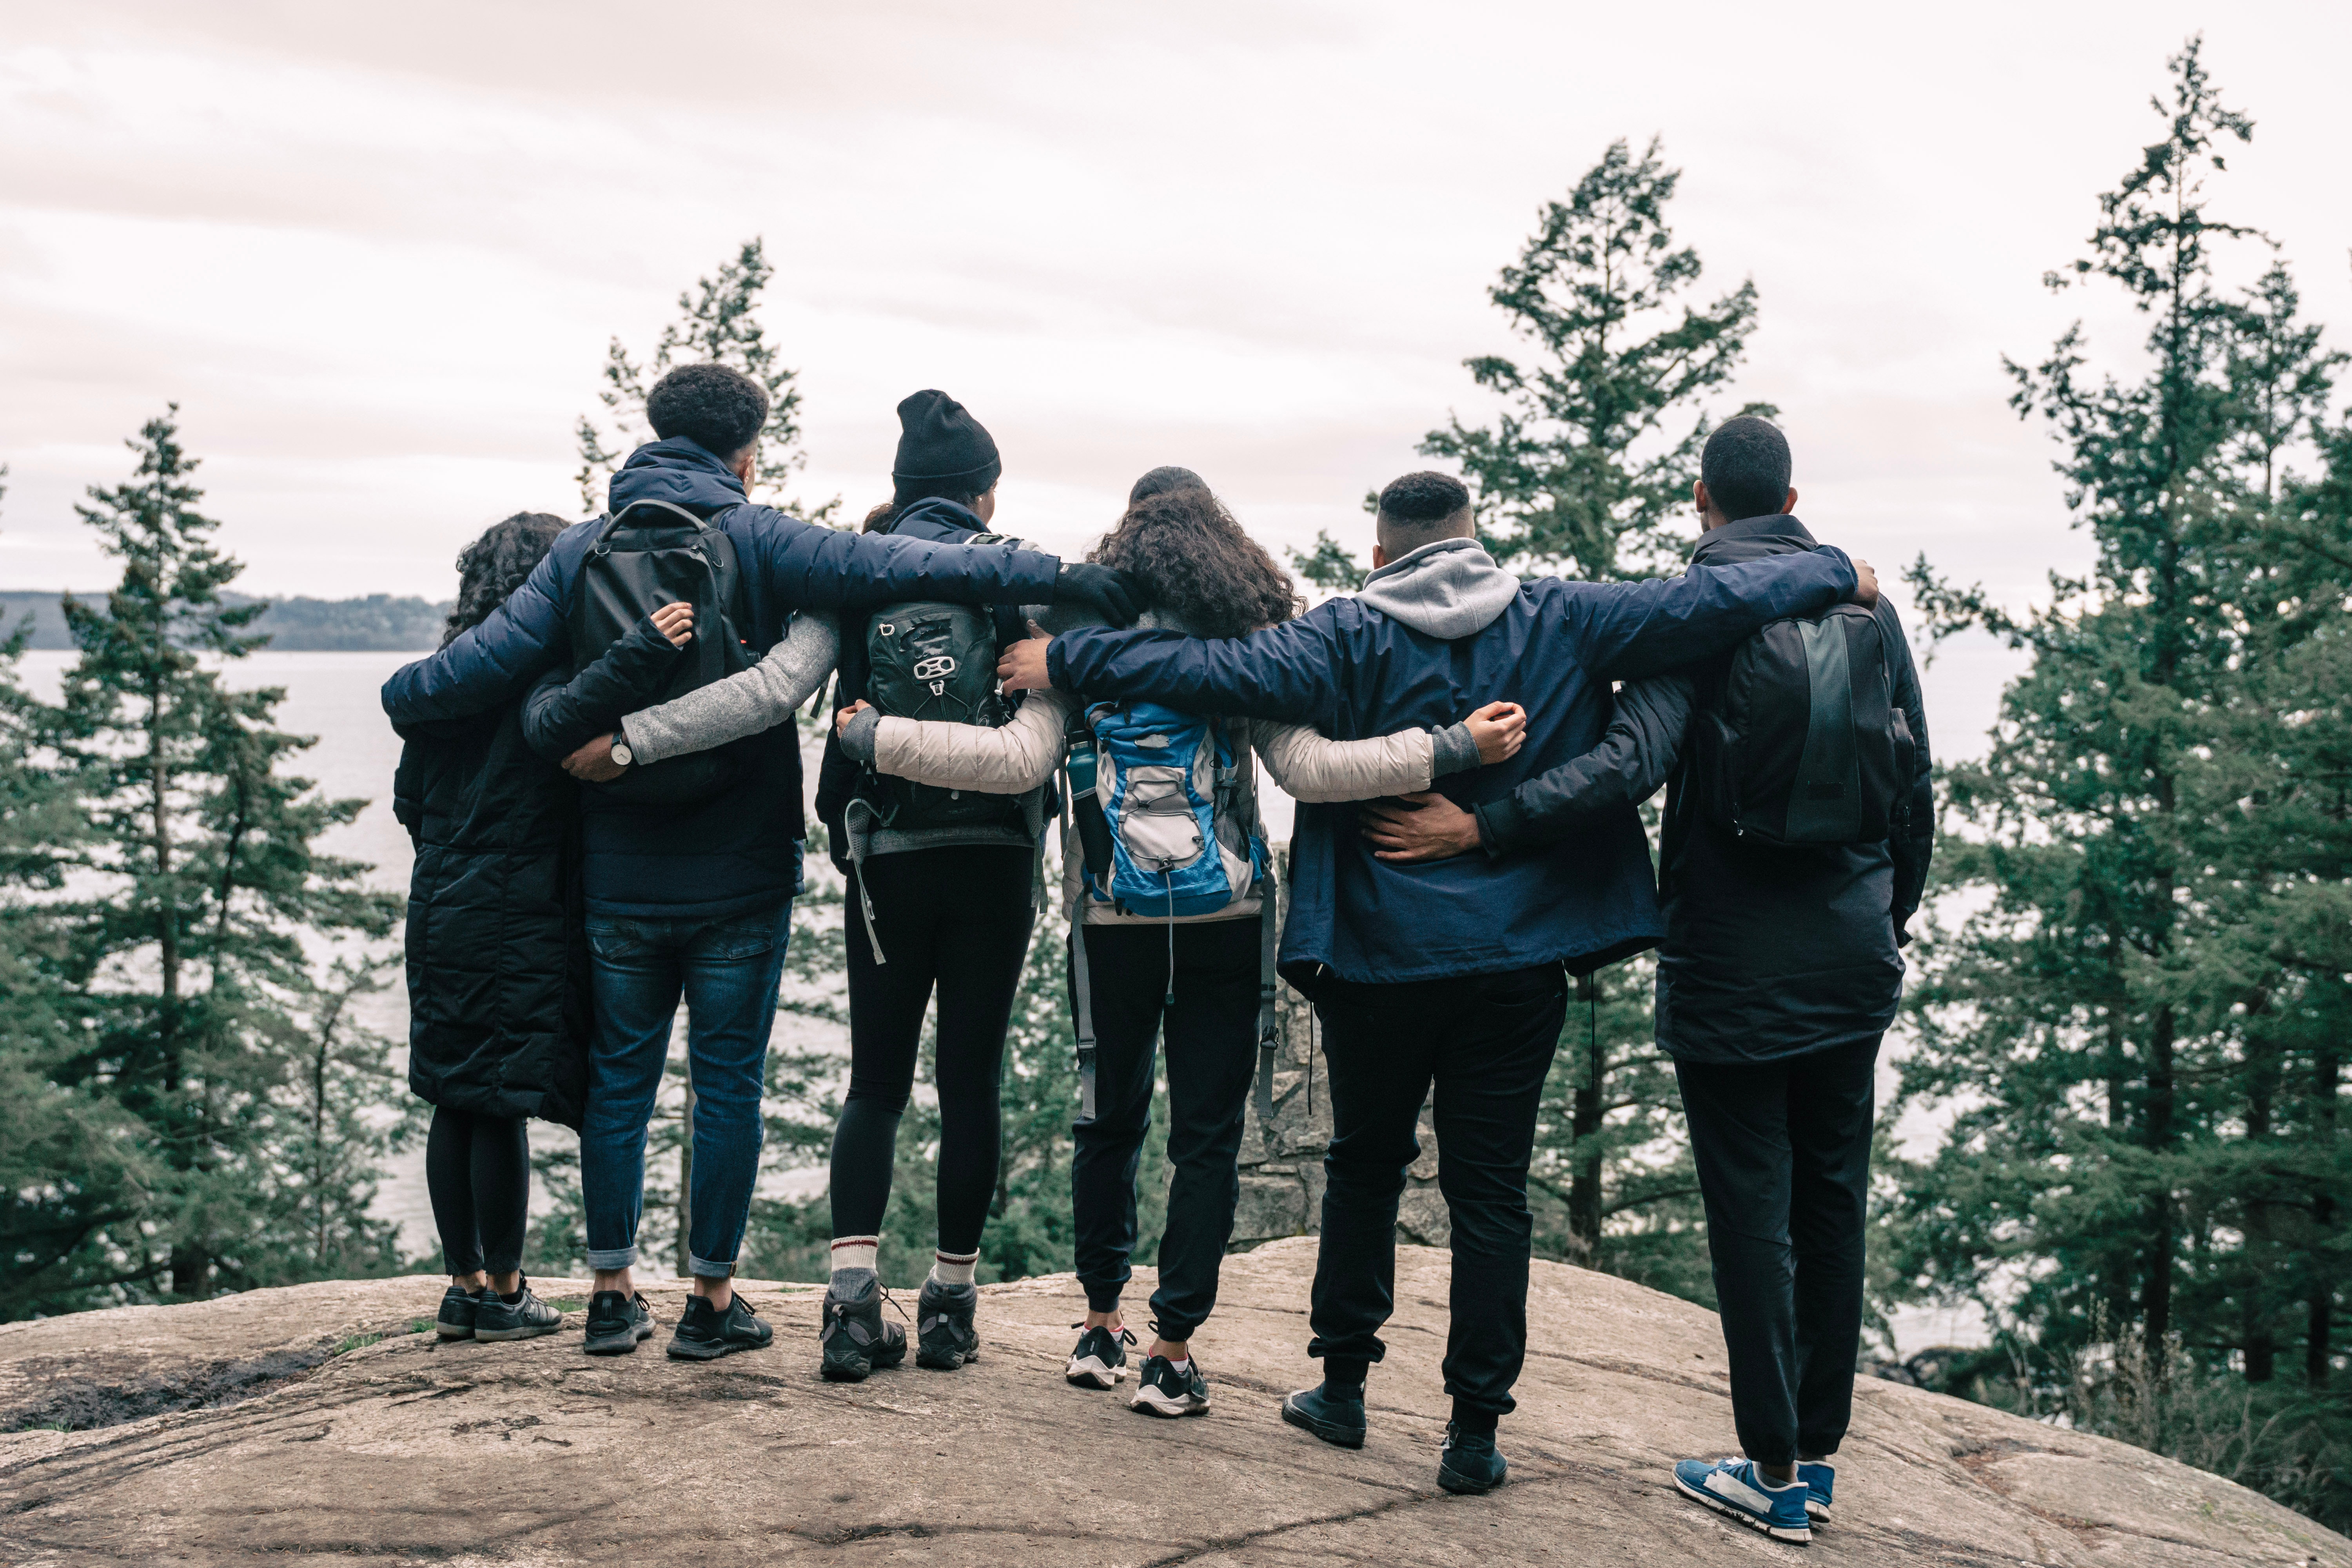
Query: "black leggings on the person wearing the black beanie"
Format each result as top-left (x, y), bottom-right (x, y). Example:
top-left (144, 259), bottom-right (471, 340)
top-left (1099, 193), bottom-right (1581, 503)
top-left (833, 844), bottom-right (1037, 1253)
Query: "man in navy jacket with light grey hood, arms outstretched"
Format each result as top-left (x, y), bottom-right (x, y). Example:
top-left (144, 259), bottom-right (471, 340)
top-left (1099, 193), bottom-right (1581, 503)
top-left (1004, 472), bottom-right (1877, 1493)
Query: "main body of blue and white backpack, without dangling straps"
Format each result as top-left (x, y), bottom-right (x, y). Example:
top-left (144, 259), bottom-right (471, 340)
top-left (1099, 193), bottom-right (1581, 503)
top-left (1087, 703), bottom-right (1265, 919)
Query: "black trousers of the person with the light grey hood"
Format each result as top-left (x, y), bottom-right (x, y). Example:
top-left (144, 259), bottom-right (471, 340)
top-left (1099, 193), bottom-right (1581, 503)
top-left (1308, 964), bottom-right (1569, 1415)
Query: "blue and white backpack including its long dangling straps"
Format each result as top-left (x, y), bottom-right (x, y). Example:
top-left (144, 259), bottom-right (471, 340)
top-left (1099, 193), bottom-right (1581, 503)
top-left (1063, 703), bottom-right (1282, 1126)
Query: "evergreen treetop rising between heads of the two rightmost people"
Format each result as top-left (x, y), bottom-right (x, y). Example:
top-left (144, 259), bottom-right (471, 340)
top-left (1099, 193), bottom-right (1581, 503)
top-left (1421, 139), bottom-right (1773, 581)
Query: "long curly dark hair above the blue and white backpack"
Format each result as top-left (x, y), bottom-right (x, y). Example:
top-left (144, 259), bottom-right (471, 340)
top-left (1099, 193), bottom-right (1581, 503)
top-left (1087, 484), bottom-right (1305, 637)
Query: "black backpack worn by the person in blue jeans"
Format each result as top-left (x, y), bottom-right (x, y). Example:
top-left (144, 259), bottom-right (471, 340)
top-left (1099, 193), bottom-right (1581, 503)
top-left (572, 501), bottom-right (750, 809)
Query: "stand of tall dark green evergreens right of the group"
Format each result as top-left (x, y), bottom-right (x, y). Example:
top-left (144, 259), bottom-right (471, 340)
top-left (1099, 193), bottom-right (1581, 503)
top-left (1882, 42), bottom-right (2352, 1523)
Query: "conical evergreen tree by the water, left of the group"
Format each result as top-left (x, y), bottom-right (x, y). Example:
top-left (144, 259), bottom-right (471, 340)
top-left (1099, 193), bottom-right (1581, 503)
top-left (40, 407), bottom-right (397, 1298)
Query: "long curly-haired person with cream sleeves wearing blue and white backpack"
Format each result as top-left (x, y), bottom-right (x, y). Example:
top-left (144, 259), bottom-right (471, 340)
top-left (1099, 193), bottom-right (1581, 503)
top-left (835, 468), bottom-right (1522, 1415)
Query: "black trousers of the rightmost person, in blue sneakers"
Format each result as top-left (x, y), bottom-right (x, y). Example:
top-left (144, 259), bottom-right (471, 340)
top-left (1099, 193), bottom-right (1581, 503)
top-left (1675, 1039), bottom-right (1879, 1465)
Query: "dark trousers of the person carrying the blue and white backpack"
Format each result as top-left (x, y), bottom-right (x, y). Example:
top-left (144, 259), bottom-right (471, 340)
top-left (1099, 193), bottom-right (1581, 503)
top-left (1070, 919), bottom-right (1258, 1340)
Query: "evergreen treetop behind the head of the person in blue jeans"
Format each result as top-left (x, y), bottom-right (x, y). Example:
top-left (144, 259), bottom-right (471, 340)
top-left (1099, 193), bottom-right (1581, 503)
top-left (574, 238), bottom-right (842, 524)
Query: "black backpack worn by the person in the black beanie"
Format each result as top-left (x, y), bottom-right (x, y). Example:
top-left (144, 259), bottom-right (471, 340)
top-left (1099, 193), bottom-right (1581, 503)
top-left (858, 585), bottom-right (1028, 832)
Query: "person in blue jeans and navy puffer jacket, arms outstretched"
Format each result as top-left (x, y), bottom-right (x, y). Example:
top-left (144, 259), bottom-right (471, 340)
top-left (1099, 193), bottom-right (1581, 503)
top-left (383, 365), bottom-right (1134, 1359)
